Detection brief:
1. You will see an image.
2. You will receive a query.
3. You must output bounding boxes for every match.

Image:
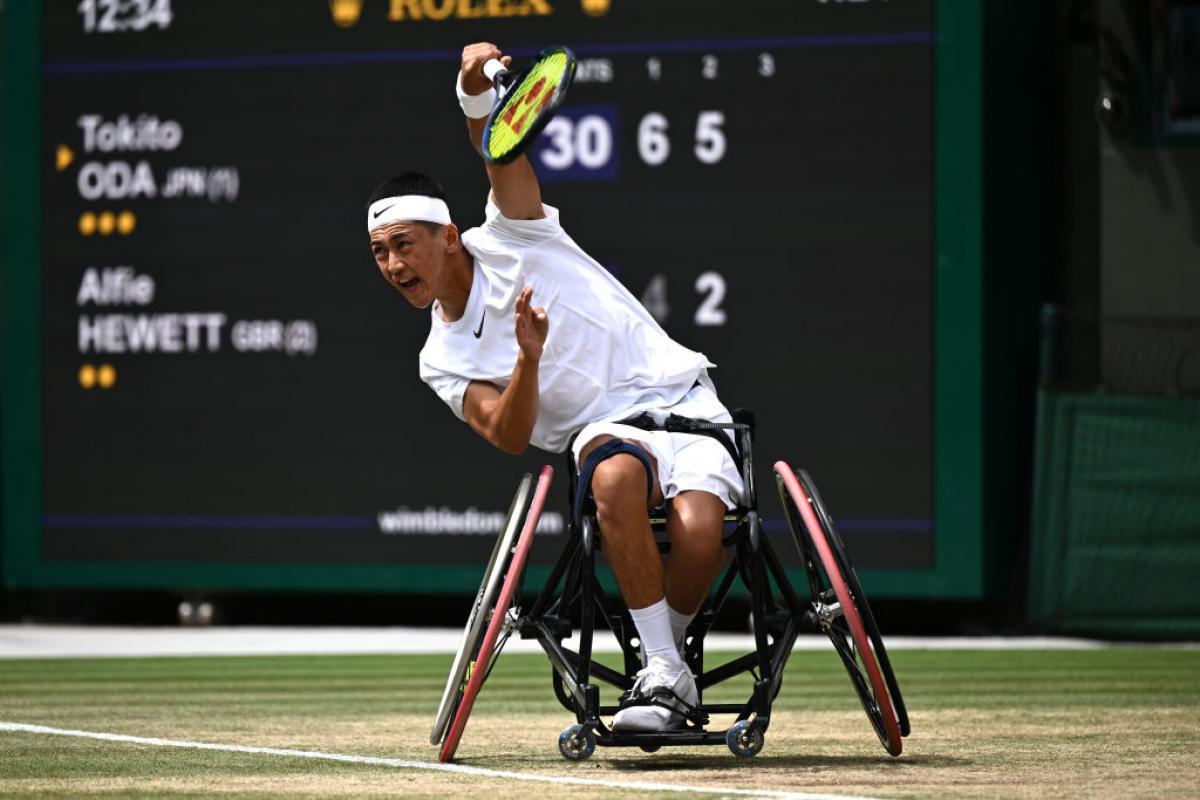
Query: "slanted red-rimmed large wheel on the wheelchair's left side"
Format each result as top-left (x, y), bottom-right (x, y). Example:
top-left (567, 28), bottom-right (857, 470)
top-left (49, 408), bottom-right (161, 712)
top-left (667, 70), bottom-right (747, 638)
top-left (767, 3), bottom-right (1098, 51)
top-left (433, 467), bottom-right (554, 762)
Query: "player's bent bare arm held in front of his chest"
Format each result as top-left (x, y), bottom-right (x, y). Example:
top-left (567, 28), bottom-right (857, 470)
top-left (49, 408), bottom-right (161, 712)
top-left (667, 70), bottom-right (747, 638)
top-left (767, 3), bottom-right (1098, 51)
top-left (462, 287), bottom-right (550, 456)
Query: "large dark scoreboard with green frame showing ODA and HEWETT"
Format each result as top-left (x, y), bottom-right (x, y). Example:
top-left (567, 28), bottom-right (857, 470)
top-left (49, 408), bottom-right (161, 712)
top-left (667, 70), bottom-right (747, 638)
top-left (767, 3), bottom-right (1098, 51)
top-left (4, 0), bottom-right (993, 594)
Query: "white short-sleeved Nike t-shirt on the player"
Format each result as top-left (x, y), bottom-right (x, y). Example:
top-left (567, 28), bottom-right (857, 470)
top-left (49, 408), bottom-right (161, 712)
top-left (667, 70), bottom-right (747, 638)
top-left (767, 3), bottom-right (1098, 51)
top-left (420, 201), bottom-right (714, 452)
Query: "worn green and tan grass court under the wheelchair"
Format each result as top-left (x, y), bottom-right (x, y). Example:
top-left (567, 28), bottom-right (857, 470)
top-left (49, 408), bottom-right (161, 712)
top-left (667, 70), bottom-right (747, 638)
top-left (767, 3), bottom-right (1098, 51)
top-left (0, 646), bottom-right (1200, 800)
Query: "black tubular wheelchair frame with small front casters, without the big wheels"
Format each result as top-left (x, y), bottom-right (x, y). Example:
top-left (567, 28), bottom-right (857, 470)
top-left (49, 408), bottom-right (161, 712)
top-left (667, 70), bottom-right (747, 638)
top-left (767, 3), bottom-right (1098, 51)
top-left (516, 422), bottom-right (902, 760)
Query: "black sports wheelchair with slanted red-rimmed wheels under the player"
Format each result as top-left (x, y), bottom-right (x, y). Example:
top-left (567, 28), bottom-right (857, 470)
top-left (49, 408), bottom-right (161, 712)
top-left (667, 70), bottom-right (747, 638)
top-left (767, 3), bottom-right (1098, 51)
top-left (430, 410), bottom-right (910, 762)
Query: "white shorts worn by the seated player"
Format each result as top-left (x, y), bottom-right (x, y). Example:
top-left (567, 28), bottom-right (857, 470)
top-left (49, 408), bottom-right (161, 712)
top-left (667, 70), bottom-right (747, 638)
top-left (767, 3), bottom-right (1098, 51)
top-left (571, 381), bottom-right (745, 509)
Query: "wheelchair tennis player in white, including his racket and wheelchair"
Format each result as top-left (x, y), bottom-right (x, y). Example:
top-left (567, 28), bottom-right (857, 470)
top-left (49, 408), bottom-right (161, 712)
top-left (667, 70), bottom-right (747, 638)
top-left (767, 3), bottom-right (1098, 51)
top-left (393, 42), bottom-right (907, 760)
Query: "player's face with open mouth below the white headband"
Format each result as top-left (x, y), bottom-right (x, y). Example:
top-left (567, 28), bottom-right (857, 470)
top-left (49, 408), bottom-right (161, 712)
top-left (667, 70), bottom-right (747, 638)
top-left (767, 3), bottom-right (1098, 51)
top-left (371, 222), bottom-right (446, 308)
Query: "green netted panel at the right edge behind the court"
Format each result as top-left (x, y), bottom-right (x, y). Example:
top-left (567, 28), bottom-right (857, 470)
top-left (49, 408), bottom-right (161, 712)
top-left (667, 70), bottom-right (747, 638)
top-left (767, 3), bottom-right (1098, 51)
top-left (1026, 391), bottom-right (1200, 638)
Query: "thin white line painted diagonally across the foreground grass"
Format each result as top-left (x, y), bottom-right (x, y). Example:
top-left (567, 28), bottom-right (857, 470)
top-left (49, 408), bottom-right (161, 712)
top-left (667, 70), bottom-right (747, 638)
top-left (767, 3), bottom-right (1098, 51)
top-left (0, 722), bottom-right (874, 800)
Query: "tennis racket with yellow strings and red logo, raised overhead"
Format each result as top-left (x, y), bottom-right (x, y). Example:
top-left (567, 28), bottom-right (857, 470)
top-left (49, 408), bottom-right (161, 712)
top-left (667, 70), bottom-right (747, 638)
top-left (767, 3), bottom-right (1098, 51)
top-left (484, 46), bottom-right (575, 164)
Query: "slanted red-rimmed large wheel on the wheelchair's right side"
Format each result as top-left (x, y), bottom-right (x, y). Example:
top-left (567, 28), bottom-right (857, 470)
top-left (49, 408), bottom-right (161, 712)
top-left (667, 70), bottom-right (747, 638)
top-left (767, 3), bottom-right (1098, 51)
top-left (775, 462), bottom-right (908, 756)
